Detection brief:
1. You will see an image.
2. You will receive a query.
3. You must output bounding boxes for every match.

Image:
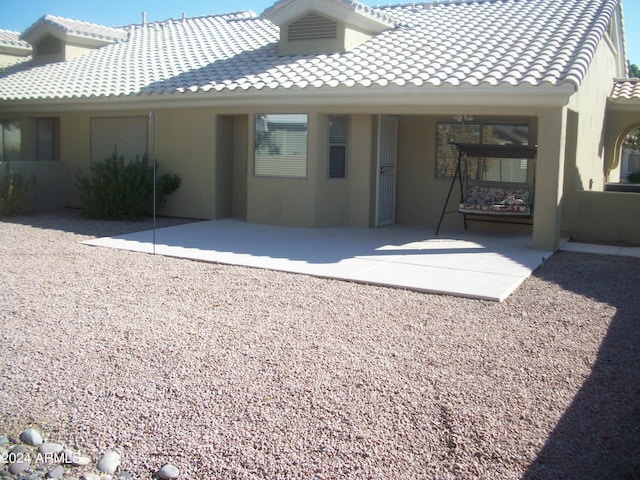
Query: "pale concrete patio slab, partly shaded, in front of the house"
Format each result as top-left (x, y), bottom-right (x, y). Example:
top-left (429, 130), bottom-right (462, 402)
top-left (83, 219), bottom-right (553, 301)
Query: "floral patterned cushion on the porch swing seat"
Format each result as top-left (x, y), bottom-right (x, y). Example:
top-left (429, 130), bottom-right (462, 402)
top-left (458, 185), bottom-right (531, 216)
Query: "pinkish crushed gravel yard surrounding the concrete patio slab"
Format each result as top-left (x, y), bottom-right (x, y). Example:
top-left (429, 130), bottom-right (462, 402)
top-left (0, 211), bottom-right (640, 479)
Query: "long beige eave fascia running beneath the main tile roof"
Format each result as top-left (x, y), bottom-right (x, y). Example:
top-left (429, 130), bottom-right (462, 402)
top-left (0, 83), bottom-right (575, 113)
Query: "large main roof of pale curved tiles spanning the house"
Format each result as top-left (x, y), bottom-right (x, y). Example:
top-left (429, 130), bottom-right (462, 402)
top-left (0, 0), bottom-right (618, 104)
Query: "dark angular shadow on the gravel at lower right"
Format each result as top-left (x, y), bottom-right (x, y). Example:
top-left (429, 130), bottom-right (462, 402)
top-left (523, 252), bottom-right (640, 480)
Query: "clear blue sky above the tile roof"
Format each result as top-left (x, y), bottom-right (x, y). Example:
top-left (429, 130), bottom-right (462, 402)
top-left (0, 0), bottom-right (640, 66)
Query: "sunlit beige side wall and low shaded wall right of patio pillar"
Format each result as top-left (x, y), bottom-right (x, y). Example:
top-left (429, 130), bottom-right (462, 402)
top-left (561, 34), bottom-right (640, 243)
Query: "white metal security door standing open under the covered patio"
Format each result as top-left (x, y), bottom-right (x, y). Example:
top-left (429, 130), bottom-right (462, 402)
top-left (376, 115), bottom-right (398, 227)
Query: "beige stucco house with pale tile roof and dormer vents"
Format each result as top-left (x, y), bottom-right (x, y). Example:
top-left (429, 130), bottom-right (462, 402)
top-left (0, 0), bottom-right (640, 250)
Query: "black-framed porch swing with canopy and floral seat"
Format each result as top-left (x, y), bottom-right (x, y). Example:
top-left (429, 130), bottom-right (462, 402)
top-left (436, 143), bottom-right (538, 235)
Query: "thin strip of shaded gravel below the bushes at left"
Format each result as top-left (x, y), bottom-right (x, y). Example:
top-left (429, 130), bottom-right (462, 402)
top-left (0, 208), bottom-right (199, 237)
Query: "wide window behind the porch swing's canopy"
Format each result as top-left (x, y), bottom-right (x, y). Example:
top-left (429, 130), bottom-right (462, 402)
top-left (436, 122), bottom-right (529, 183)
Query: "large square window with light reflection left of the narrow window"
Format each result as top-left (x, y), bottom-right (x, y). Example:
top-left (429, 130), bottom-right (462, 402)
top-left (254, 114), bottom-right (309, 178)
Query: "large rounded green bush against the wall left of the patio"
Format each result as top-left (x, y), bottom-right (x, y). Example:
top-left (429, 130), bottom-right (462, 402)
top-left (76, 151), bottom-right (181, 220)
